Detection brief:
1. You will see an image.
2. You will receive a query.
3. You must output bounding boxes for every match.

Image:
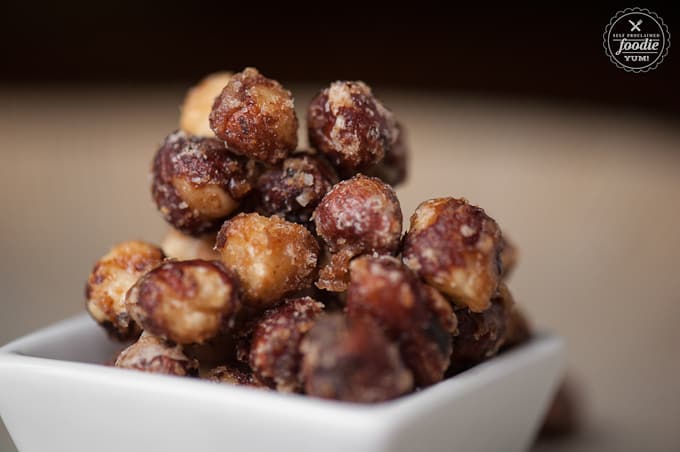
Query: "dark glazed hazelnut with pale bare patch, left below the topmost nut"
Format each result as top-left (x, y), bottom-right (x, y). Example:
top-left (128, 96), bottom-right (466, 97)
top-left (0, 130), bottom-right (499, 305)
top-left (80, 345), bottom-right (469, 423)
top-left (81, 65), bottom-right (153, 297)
top-left (151, 131), bottom-right (255, 236)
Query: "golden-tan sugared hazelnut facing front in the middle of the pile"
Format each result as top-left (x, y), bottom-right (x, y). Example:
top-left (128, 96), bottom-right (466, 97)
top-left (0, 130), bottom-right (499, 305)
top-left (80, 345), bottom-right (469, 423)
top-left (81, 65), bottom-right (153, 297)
top-left (215, 213), bottom-right (319, 308)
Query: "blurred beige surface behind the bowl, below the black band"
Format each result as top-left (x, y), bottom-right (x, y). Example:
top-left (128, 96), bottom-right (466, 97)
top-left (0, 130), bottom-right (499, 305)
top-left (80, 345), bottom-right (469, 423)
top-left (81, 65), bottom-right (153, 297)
top-left (0, 87), bottom-right (680, 451)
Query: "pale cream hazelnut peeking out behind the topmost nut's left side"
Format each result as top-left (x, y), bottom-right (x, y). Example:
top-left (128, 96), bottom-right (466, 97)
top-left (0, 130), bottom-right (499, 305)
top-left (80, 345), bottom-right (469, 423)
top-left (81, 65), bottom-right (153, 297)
top-left (179, 72), bottom-right (232, 137)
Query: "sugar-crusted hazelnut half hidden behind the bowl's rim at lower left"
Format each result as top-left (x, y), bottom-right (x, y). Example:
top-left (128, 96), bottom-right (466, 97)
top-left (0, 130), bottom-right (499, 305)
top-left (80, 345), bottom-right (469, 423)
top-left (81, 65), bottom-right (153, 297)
top-left (115, 332), bottom-right (198, 377)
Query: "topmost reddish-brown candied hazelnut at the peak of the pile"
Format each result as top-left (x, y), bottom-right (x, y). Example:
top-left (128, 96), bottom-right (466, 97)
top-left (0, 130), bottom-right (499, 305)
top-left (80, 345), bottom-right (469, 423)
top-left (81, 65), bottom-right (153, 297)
top-left (210, 68), bottom-right (298, 164)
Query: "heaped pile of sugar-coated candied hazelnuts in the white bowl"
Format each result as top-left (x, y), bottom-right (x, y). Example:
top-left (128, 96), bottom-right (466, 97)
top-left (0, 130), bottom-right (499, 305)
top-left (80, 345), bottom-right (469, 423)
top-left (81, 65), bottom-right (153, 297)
top-left (86, 68), bottom-right (530, 402)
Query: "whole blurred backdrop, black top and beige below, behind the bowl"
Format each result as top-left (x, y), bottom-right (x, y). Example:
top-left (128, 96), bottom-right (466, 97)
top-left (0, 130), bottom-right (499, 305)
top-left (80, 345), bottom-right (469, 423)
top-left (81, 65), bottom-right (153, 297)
top-left (0, 1), bottom-right (680, 451)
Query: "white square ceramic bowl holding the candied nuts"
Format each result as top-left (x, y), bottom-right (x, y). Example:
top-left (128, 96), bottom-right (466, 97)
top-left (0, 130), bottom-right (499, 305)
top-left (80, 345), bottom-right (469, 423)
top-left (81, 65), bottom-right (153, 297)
top-left (0, 315), bottom-right (564, 452)
